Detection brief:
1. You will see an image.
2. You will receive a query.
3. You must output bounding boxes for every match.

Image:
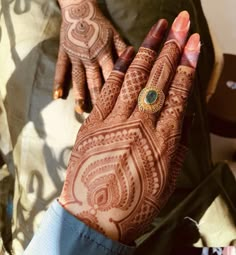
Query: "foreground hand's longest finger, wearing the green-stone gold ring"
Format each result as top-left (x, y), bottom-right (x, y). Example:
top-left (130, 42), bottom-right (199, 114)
top-left (132, 11), bottom-right (190, 123)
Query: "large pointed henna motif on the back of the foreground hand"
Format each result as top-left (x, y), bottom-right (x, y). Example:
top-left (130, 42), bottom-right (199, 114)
top-left (61, 121), bottom-right (171, 242)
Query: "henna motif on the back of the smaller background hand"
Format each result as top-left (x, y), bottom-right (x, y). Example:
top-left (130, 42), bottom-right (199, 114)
top-left (62, 1), bottom-right (113, 62)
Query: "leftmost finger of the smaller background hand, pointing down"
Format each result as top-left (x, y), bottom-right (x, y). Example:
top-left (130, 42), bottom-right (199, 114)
top-left (53, 46), bottom-right (70, 99)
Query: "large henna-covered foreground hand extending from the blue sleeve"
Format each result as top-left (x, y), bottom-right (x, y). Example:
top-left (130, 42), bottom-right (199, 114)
top-left (59, 11), bottom-right (200, 244)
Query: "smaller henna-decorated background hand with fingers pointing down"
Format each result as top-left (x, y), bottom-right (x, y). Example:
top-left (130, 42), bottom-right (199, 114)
top-left (53, 0), bottom-right (126, 113)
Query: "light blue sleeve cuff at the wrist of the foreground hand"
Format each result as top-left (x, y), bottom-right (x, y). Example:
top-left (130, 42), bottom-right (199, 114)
top-left (23, 201), bottom-right (135, 255)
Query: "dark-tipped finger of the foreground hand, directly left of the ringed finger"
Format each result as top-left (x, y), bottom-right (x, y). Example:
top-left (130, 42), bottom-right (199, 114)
top-left (111, 19), bottom-right (168, 119)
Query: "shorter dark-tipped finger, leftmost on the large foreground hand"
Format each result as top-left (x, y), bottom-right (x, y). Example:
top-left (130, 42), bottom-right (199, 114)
top-left (89, 46), bottom-right (135, 120)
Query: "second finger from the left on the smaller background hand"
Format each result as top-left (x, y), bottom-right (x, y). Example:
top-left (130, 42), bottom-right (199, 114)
top-left (72, 60), bottom-right (85, 114)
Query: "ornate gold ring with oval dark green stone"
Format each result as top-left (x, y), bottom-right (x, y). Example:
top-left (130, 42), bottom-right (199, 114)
top-left (138, 86), bottom-right (165, 113)
